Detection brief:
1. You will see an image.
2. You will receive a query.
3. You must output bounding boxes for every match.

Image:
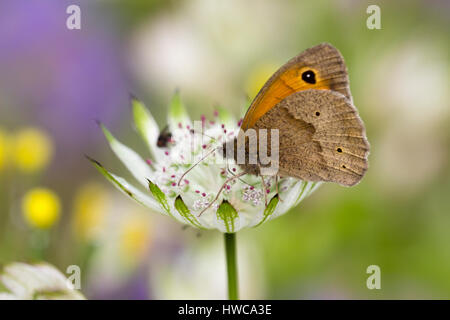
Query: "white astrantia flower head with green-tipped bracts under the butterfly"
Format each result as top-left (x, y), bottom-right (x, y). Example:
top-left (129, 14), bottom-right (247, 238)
top-left (92, 94), bottom-right (319, 233)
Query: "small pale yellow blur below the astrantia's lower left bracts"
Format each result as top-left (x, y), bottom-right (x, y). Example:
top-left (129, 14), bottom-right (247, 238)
top-left (120, 216), bottom-right (151, 263)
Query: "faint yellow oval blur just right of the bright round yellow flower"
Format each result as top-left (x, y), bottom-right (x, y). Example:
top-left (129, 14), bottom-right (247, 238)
top-left (73, 182), bottom-right (109, 240)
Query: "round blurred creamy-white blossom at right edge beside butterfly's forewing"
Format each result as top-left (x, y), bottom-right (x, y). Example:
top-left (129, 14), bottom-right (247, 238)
top-left (373, 39), bottom-right (450, 130)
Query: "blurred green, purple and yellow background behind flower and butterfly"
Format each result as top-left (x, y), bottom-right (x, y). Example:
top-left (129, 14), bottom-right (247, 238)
top-left (0, 0), bottom-right (450, 299)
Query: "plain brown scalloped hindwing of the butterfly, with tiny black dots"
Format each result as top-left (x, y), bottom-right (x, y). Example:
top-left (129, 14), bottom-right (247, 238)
top-left (254, 89), bottom-right (369, 186)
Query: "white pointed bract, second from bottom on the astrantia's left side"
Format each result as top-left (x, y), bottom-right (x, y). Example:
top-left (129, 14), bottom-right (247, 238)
top-left (100, 123), bottom-right (152, 186)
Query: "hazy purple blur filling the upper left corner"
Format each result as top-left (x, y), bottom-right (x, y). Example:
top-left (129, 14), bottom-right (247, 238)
top-left (0, 0), bottom-right (129, 168)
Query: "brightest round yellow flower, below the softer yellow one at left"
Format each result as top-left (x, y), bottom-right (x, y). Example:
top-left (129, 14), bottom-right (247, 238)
top-left (22, 188), bottom-right (61, 229)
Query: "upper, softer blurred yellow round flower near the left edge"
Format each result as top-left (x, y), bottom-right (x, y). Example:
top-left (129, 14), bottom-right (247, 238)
top-left (13, 128), bottom-right (53, 173)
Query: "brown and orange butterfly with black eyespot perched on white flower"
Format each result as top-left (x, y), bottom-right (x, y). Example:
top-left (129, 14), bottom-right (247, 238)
top-left (223, 43), bottom-right (369, 186)
